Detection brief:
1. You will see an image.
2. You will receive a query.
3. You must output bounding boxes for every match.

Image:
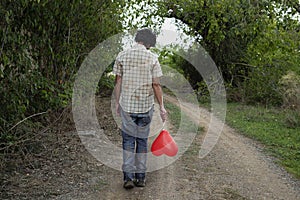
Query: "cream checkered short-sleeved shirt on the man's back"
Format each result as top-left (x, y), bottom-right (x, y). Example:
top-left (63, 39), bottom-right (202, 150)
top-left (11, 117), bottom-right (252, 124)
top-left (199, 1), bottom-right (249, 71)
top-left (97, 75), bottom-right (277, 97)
top-left (113, 44), bottom-right (162, 113)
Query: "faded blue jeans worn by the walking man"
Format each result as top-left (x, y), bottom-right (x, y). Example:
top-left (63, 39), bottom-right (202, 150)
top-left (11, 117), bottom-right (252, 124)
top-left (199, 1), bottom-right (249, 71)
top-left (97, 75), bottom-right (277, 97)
top-left (121, 108), bottom-right (153, 181)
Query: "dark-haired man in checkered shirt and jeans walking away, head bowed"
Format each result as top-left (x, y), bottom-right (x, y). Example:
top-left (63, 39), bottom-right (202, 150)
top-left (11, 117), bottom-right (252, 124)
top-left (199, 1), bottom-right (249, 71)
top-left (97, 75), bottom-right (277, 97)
top-left (113, 29), bottom-right (167, 189)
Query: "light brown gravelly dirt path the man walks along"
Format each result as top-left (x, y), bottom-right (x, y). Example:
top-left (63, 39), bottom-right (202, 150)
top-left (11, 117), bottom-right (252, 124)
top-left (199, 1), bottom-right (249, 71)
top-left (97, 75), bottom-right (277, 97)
top-left (50, 97), bottom-right (300, 200)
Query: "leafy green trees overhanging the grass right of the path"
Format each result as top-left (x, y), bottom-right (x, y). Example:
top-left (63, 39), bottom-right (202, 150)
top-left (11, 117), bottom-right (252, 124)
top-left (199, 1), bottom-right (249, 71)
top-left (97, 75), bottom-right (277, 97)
top-left (127, 0), bottom-right (299, 104)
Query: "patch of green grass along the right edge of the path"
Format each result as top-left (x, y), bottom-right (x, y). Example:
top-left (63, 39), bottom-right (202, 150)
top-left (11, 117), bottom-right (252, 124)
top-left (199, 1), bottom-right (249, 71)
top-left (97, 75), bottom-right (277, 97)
top-left (226, 103), bottom-right (300, 178)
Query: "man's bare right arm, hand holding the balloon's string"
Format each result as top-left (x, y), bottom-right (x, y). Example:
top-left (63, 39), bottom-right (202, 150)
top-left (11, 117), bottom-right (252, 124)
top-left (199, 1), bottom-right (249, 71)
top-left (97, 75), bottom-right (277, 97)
top-left (152, 78), bottom-right (167, 122)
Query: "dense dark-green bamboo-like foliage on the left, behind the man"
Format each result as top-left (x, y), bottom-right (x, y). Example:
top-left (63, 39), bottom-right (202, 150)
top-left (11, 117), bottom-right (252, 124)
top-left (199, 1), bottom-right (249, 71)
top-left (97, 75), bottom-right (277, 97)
top-left (0, 0), bottom-right (124, 143)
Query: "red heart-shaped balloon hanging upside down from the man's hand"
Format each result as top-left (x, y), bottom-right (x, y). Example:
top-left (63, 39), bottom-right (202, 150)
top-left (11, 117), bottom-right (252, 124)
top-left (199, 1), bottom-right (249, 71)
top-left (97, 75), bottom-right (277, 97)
top-left (151, 129), bottom-right (178, 156)
